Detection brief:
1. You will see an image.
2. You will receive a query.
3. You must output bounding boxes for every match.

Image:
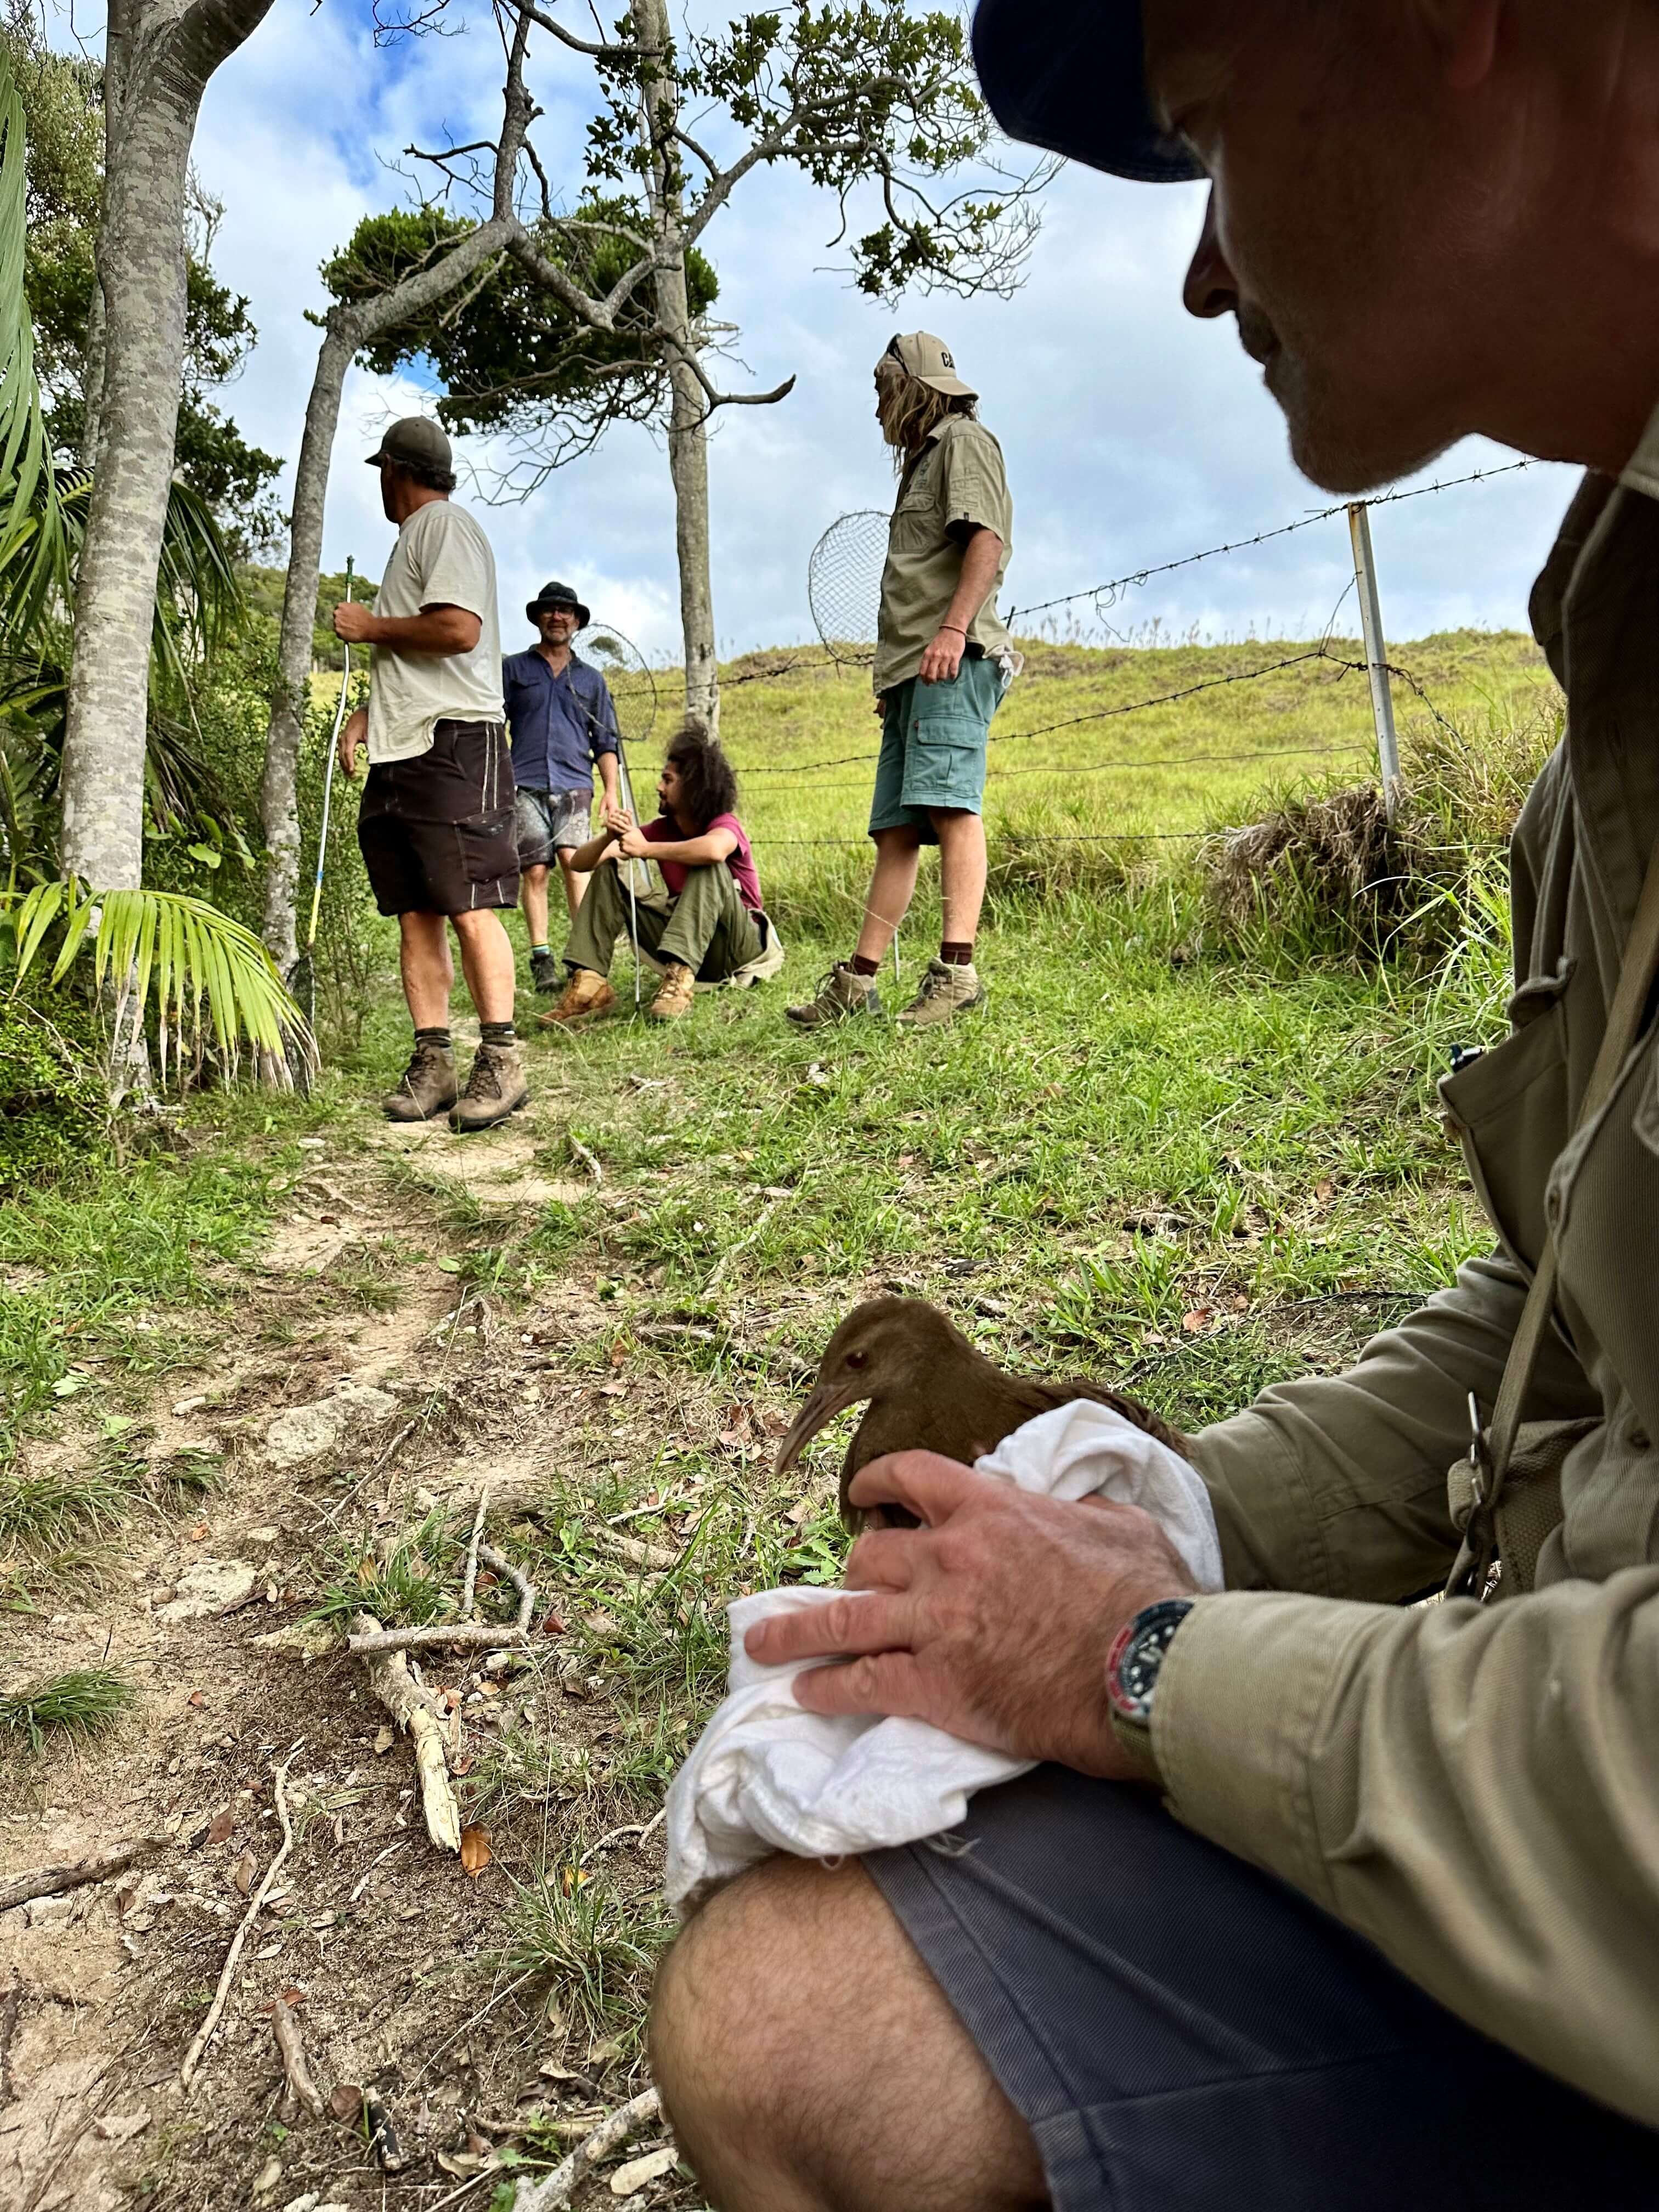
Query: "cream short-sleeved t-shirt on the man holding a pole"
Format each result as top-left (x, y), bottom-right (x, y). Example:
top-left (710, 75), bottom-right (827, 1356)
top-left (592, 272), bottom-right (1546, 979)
top-left (369, 500), bottom-right (506, 763)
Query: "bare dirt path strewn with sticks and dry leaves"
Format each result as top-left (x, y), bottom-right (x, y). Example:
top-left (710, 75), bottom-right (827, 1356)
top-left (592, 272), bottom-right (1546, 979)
top-left (0, 1102), bottom-right (738, 2212)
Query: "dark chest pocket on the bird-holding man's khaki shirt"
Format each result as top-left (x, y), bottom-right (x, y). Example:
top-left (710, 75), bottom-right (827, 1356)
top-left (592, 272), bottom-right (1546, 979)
top-left (1440, 995), bottom-right (1571, 1272)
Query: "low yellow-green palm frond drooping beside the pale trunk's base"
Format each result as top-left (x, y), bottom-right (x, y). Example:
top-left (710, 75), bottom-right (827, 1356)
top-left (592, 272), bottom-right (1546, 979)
top-left (0, 881), bottom-right (317, 1082)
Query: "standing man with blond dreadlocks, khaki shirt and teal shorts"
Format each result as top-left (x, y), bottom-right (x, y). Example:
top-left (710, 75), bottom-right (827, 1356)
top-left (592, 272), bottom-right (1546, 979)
top-left (789, 330), bottom-right (1015, 1029)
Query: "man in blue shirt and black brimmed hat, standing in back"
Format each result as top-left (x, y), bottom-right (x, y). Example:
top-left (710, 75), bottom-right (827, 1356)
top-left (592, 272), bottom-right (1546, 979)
top-left (502, 584), bottom-right (617, 991)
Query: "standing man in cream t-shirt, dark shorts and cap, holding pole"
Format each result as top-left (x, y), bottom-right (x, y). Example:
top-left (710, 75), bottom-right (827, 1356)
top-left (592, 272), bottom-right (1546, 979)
top-left (334, 416), bottom-right (529, 1132)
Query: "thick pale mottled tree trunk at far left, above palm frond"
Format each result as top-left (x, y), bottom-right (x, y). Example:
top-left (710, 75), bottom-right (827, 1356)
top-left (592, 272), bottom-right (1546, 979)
top-left (62, 0), bottom-right (270, 889)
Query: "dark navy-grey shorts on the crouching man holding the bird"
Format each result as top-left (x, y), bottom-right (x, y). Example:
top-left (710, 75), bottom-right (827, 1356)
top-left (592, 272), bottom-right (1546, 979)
top-left (865, 1768), bottom-right (1659, 2212)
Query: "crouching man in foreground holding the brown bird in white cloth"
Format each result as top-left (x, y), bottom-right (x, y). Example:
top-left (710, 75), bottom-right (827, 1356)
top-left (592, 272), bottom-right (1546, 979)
top-left (650, 0), bottom-right (1659, 2212)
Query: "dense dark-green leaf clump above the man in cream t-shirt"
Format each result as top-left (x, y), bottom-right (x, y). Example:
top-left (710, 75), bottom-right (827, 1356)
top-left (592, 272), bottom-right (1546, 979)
top-left (323, 197), bottom-right (719, 442)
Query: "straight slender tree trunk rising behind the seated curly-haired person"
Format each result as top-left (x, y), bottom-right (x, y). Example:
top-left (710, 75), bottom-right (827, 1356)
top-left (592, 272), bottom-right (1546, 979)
top-left (633, 0), bottom-right (721, 735)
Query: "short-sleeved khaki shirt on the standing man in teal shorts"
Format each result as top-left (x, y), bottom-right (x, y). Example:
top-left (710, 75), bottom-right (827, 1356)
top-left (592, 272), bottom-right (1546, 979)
top-left (876, 416), bottom-right (1013, 692)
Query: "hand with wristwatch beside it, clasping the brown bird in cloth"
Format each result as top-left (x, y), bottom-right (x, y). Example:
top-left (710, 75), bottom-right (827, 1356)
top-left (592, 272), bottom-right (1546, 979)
top-left (746, 1451), bottom-right (1197, 1781)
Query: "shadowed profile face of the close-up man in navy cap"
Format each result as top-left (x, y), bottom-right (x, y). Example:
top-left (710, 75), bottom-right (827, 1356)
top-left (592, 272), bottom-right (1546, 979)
top-left (1144, 0), bottom-right (1513, 493)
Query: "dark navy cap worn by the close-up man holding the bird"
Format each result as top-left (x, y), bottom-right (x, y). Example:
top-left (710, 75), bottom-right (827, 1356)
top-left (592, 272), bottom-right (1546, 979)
top-left (973, 0), bottom-right (1203, 184)
